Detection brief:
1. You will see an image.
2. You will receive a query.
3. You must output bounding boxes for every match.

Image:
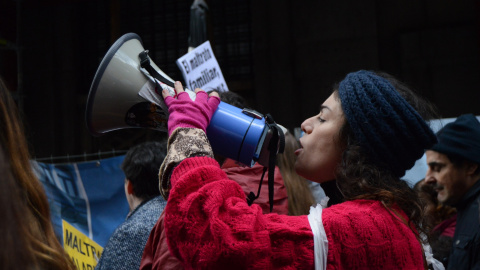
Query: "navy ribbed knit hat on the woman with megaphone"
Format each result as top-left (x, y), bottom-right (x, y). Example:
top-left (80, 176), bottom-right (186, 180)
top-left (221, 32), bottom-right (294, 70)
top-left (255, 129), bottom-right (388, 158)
top-left (338, 70), bottom-right (436, 177)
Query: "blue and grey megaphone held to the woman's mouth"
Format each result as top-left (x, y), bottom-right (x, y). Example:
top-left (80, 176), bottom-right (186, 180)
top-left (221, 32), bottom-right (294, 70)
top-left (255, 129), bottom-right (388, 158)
top-left (86, 33), bottom-right (283, 167)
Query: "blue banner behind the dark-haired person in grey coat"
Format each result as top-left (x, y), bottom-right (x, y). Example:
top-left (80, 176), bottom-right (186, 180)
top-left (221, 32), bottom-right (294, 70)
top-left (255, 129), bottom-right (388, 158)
top-left (32, 156), bottom-right (129, 247)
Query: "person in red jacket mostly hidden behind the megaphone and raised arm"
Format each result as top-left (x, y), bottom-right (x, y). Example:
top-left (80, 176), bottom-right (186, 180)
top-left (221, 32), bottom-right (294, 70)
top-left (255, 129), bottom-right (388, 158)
top-left (140, 91), bottom-right (290, 270)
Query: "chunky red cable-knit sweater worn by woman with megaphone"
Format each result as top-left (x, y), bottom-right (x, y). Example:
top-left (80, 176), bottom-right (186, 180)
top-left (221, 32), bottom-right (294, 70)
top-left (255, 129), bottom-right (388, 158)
top-left (164, 157), bottom-right (423, 269)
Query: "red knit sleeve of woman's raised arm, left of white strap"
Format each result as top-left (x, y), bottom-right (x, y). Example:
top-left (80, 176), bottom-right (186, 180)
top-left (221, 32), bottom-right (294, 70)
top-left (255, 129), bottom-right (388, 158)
top-left (160, 127), bottom-right (314, 269)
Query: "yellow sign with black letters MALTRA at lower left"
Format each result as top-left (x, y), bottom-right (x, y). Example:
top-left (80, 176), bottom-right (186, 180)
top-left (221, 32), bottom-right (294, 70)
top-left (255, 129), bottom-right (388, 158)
top-left (62, 220), bottom-right (103, 270)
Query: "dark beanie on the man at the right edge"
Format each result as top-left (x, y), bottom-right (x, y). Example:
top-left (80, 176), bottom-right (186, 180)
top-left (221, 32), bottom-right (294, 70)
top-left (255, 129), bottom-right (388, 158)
top-left (431, 114), bottom-right (480, 164)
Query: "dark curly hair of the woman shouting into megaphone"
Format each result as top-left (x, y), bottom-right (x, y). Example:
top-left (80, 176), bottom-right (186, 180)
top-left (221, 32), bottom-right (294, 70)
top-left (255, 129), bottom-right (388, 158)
top-left (334, 72), bottom-right (436, 243)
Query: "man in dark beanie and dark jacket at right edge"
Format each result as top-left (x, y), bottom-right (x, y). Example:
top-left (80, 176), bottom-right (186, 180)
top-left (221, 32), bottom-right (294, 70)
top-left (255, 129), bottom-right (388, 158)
top-left (425, 114), bottom-right (480, 269)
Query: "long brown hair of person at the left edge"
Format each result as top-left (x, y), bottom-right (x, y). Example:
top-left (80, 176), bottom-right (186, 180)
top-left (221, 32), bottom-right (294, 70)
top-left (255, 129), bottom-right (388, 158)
top-left (0, 78), bottom-right (75, 270)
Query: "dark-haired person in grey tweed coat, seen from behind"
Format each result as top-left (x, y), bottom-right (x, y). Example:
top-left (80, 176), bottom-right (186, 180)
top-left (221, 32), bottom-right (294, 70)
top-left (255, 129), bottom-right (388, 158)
top-left (95, 141), bottom-right (167, 269)
